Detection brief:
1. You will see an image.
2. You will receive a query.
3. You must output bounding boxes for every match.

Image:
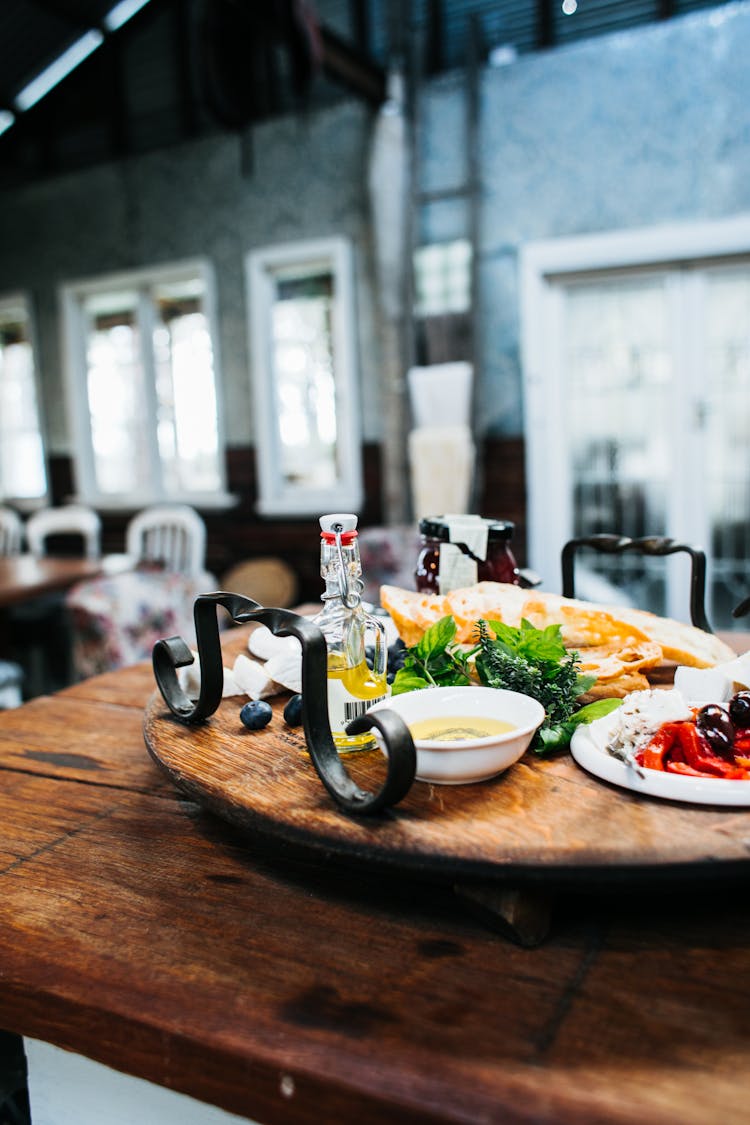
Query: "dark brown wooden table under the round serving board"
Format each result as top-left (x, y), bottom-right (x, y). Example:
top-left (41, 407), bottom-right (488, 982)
top-left (0, 632), bottom-right (750, 1125)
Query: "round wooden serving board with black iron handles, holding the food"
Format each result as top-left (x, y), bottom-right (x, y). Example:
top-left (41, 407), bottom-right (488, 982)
top-left (144, 693), bottom-right (750, 882)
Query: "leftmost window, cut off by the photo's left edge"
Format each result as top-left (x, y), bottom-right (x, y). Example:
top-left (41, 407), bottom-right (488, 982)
top-left (0, 296), bottom-right (47, 506)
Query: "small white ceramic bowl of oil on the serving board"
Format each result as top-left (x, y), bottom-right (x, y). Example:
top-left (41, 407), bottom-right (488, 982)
top-left (372, 686), bottom-right (544, 785)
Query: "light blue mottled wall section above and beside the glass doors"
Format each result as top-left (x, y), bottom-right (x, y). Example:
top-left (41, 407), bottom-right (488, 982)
top-left (425, 2), bottom-right (750, 434)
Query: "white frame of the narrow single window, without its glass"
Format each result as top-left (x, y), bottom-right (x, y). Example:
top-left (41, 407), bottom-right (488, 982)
top-left (245, 237), bottom-right (363, 518)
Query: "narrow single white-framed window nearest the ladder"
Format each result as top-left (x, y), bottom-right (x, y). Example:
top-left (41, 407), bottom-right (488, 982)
top-left (246, 239), bottom-right (362, 515)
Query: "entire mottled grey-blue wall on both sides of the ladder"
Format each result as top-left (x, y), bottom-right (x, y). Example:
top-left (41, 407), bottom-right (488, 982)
top-left (0, 0), bottom-right (750, 452)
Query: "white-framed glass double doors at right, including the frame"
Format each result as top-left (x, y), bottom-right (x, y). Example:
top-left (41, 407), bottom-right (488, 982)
top-left (524, 214), bottom-right (750, 629)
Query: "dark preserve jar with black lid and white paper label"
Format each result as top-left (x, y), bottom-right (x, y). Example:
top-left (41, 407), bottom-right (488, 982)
top-left (415, 515), bottom-right (521, 594)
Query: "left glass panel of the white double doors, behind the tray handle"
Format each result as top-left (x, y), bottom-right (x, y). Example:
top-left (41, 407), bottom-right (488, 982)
top-left (561, 273), bottom-right (678, 613)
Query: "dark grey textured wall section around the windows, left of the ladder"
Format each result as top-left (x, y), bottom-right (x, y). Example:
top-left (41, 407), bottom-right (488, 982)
top-left (0, 102), bottom-right (378, 452)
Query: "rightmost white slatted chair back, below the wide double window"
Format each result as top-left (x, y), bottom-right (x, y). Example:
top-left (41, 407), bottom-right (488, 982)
top-left (125, 504), bottom-right (206, 575)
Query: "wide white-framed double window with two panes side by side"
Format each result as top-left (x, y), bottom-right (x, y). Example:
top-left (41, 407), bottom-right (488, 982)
top-left (63, 262), bottom-right (228, 507)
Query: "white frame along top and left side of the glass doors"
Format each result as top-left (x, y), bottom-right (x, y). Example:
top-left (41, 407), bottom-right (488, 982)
top-left (519, 214), bottom-right (750, 603)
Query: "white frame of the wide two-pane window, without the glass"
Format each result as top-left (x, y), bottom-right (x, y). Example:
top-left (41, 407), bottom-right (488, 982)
top-left (58, 258), bottom-right (234, 511)
